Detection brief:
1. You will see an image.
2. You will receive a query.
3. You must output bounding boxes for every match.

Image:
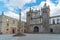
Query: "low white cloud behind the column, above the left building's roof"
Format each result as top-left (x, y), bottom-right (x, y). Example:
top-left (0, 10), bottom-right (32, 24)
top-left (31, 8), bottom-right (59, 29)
top-left (4, 8), bottom-right (29, 22)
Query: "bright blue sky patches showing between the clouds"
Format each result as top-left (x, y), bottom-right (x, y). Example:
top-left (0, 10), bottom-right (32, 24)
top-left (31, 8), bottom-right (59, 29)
top-left (0, 0), bottom-right (58, 13)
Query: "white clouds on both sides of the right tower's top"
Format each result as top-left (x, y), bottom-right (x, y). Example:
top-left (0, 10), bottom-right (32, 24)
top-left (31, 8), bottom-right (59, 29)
top-left (33, 0), bottom-right (60, 16)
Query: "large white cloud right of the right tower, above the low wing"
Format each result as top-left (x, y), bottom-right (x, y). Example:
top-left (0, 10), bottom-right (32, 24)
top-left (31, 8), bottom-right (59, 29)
top-left (47, 0), bottom-right (60, 16)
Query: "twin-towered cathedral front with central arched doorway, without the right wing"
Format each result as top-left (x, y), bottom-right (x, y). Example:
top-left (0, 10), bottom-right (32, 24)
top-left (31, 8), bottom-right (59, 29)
top-left (26, 3), bottom-right (50, 32)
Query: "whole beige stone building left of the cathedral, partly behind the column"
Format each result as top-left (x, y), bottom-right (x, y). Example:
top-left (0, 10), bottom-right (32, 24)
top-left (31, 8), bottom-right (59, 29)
top-left (0, 13), bottom-right (24, 34)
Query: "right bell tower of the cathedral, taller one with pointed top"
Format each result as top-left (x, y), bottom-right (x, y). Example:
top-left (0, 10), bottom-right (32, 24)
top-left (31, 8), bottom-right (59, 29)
top-left (41, 2), bottom-right (50, 32)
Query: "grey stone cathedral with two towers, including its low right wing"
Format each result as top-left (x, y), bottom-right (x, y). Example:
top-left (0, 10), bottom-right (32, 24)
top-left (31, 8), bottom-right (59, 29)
top-left (26, 3), bottom-right (60, 33)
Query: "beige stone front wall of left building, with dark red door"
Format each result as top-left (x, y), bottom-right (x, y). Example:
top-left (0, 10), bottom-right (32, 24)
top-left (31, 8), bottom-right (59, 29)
top-left (1, 15), bottom-right (18, 34)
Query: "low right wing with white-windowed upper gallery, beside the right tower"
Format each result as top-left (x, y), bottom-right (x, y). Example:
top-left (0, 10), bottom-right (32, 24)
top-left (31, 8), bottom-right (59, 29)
top-left (49, 15), bottom-right (60, 33)
